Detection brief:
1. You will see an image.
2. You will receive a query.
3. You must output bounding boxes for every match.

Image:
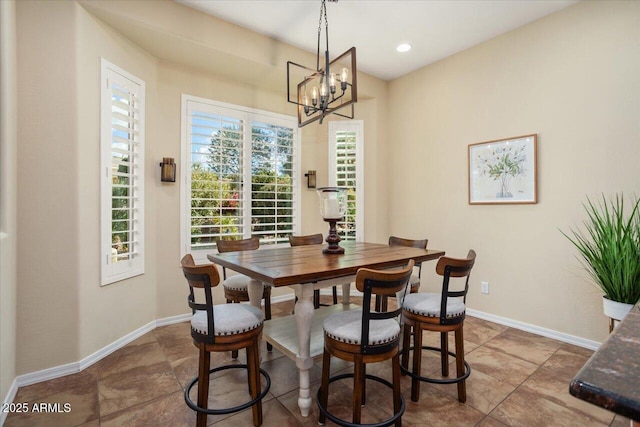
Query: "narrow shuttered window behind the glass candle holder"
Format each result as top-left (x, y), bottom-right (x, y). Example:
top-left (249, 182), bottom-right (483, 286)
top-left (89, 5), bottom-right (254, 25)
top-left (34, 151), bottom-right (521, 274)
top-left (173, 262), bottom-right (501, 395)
top-left (329, 120), bottom-right (364, 241)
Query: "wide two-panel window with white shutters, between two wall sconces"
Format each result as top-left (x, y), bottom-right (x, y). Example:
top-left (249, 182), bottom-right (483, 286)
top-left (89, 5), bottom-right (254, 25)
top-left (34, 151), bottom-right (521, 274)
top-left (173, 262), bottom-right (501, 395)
top-left (182, 95), bottom-right (299, 259)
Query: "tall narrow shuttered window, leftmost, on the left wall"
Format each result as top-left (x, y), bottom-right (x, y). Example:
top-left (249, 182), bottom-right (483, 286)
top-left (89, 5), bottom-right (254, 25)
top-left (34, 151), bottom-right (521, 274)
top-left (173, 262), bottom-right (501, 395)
top-left (100, 59), bottom-right (145, 285)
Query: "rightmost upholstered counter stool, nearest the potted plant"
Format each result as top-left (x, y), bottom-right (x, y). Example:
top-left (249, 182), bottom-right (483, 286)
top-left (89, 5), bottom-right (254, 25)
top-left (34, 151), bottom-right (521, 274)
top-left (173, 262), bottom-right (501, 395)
top-left (402, 250), bottom-right (476, 403)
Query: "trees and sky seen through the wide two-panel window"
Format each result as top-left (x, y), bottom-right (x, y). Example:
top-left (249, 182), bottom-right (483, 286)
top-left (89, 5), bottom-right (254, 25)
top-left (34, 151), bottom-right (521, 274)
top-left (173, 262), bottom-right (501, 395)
top-left (191, 124), bottom-right (293, 249)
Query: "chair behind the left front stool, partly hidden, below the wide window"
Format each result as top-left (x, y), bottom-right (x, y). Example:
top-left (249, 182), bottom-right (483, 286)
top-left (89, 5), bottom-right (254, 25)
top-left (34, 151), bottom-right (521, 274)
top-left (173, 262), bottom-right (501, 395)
top-left (216, 236), bottom-right (273, 358)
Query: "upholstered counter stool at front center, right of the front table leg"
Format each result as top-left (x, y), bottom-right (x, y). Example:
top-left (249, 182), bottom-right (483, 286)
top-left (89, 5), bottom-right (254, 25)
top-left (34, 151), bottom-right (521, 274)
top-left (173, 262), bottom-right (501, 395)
top-left (318, 260), bottom-right (414, 427)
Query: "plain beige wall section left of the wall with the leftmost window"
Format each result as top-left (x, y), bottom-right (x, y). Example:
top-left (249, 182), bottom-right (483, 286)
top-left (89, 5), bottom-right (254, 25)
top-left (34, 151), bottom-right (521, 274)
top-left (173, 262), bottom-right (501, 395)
top-left (16, 2), bottom-right (81, 374)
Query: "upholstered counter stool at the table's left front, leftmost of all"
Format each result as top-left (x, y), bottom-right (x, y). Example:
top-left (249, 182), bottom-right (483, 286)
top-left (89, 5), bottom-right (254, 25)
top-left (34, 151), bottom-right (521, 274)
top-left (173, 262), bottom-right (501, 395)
top-left (180, 254), bottom-right (271, 427)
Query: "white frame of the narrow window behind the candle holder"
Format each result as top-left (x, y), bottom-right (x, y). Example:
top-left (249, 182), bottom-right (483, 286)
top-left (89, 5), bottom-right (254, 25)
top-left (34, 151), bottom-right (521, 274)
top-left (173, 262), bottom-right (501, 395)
top-left (327, 120), bottom-right (365, 242)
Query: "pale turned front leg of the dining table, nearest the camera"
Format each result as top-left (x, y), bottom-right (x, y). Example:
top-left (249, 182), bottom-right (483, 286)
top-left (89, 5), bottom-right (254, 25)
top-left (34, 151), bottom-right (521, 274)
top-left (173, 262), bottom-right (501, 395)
top-left (294, 285), bottom-right (313, 417)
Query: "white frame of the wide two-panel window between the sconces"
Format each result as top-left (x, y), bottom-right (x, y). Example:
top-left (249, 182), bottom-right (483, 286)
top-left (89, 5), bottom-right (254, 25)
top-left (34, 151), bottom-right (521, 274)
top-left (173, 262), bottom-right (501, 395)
top-left (180, 94), bottom-right (302, 262)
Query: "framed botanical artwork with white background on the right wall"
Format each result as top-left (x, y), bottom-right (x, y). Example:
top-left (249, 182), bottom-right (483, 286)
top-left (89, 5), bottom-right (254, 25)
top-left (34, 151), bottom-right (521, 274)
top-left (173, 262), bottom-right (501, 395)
top-left (469, 134), bottom-right (538, 205)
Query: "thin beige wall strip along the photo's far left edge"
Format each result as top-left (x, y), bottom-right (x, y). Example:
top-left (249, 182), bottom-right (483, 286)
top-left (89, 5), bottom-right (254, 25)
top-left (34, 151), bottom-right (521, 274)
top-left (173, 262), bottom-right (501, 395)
top-left (0, 1), bottom-right (18, 404)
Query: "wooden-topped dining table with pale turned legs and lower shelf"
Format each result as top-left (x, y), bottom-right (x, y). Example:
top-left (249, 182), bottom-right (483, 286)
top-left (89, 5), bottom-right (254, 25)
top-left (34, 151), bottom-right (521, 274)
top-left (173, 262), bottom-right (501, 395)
top-left (207, 241), bottom-right (444, 417)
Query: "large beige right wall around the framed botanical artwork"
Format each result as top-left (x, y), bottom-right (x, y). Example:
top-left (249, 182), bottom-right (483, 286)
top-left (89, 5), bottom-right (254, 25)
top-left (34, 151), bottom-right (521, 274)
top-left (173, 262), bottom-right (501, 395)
top-left (389, 2), bottom-right (640, 341)
